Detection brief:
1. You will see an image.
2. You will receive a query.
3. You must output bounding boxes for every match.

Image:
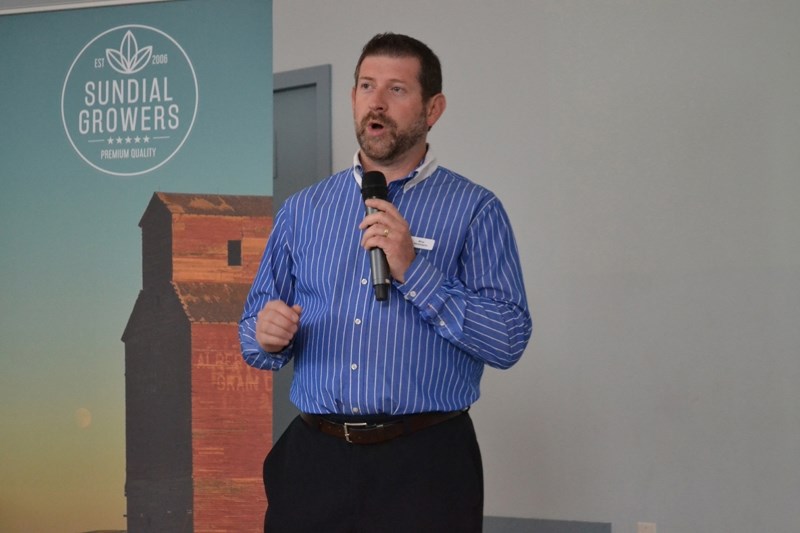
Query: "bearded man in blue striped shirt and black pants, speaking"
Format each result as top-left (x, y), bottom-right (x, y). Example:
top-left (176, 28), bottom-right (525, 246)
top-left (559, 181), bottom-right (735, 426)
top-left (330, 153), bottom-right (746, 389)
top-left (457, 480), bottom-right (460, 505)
top-left (240, 34), bottom-right (531, 532)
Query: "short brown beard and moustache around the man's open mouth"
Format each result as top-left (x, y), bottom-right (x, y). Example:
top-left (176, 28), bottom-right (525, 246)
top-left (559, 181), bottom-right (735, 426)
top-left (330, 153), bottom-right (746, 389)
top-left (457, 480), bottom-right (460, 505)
top-left (356, 110), bottom-right (428, 164)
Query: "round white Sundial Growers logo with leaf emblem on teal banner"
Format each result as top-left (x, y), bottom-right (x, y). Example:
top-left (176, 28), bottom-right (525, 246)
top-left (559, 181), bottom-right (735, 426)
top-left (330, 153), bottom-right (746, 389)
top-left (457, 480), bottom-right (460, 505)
top-left (61, 24), bottom-right (198, 176)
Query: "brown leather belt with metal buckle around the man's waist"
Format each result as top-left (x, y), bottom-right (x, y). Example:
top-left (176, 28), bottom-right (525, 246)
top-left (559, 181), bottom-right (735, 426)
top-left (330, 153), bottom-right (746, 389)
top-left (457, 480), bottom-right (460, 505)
top-left (300, 410), bottom-right (467, 444)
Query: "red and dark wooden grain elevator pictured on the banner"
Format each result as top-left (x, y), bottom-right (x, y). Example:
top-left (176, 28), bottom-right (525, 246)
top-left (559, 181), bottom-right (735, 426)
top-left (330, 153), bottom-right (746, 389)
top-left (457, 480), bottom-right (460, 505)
top-left (122, 192), bottom-right (273, 533)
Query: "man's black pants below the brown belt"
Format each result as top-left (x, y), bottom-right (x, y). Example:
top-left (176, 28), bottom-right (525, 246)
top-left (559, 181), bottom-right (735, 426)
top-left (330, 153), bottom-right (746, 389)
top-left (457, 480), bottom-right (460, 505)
top-left (264, 413), bottom-right (483, 533)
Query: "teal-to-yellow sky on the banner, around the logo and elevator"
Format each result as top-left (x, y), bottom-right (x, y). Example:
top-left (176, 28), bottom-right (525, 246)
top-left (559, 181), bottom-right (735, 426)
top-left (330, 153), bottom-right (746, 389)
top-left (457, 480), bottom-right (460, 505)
top-left (0, 0), bottom-right (272, 532)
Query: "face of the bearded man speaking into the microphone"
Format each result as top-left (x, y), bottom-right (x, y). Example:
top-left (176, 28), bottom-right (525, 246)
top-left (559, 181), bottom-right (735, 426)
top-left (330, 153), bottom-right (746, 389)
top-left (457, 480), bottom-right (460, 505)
top-left (353, 56), bottom-right (432, 165)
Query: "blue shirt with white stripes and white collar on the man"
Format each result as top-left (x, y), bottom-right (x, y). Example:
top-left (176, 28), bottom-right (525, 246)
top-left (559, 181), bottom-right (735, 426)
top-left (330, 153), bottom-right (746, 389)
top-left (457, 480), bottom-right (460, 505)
top-left (239, 150), bottom-right (531, 415)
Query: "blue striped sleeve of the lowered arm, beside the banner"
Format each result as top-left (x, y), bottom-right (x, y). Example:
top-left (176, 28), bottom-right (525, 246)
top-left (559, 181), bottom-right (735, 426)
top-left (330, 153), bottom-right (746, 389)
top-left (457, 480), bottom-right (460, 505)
top-left (239, 205), bottom-right (294, 370)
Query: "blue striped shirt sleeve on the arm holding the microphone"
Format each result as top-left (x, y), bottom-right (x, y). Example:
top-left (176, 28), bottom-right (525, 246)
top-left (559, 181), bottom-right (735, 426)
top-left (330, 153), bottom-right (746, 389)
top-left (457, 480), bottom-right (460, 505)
top-left (397, 198), bottom-right (532, 368)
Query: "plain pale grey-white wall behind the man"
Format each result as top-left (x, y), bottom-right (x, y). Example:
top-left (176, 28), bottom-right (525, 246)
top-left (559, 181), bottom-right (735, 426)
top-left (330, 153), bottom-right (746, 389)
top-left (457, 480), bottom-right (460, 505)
top-left (274, 0), bottom-right (800, 533)
